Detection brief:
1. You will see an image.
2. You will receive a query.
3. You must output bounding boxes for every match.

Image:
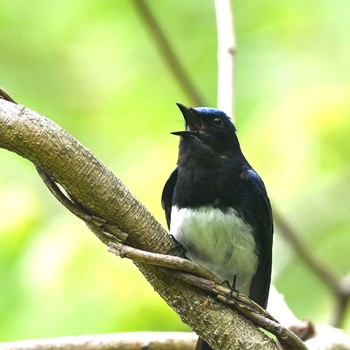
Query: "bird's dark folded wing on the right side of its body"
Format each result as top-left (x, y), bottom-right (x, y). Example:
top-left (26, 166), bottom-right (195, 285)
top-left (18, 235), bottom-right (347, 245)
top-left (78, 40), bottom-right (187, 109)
top-left (242, 169), bottom-right (273, 307)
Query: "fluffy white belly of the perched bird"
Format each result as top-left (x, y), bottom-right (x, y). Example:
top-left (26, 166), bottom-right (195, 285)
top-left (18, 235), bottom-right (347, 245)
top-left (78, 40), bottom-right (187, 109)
top-left (170, 206), bottom-right (258, 295)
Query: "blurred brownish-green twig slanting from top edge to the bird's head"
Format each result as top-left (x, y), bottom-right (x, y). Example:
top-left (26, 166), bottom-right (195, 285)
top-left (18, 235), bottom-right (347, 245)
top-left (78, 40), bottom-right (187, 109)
top-left (133, 0), bottom-right (204, 106)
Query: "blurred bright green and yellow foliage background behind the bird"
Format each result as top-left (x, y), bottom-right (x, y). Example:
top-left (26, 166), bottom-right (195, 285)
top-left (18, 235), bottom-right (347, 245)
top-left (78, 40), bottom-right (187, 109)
top-left (0, 0), bottom-right (350, 341)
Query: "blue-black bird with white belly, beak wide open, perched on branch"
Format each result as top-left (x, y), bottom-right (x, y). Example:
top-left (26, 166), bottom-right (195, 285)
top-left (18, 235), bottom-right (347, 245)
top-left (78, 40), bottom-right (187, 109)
top-left (162, 103), bottom-right (273, 350)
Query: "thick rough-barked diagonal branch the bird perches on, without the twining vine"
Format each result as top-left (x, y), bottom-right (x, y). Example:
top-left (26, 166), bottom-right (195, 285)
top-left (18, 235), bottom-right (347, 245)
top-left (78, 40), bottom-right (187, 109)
top-left (0, 100), bottom-right (276, 349)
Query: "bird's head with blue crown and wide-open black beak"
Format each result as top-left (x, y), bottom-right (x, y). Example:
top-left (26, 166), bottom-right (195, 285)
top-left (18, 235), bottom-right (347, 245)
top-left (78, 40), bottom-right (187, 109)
top-left (172, 103), bottom-right (240, 153)
